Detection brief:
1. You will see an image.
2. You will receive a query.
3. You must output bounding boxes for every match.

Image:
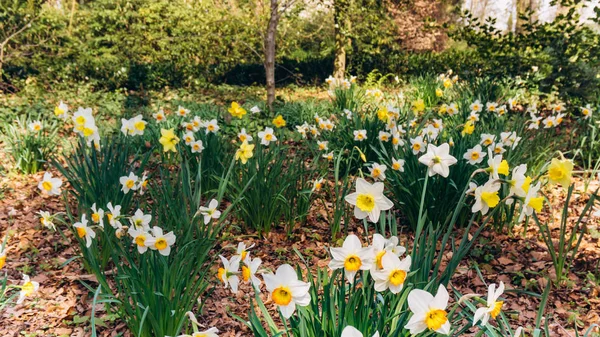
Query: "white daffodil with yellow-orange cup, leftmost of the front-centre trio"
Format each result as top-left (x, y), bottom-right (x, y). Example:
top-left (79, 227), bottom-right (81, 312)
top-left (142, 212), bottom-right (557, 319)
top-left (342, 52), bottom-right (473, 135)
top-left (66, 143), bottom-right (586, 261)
top-left (329, 234), bottom-right (374, 283)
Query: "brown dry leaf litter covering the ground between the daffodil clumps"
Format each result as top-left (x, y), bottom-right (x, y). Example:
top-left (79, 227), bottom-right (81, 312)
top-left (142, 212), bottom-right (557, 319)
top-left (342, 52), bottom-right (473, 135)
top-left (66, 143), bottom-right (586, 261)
top-left (0, 166), bottom-right (600, 337)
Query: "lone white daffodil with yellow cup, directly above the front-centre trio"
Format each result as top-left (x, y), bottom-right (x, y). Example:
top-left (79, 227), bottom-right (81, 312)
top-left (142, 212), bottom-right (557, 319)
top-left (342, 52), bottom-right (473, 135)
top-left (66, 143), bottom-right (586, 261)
top-left (344, 178), bottom-right (394, 222)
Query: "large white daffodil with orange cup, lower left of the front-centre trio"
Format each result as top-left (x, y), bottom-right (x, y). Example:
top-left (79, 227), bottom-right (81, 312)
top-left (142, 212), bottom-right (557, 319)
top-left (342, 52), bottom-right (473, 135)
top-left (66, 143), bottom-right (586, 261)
top-left (263, 264), bottom-right (310, 318)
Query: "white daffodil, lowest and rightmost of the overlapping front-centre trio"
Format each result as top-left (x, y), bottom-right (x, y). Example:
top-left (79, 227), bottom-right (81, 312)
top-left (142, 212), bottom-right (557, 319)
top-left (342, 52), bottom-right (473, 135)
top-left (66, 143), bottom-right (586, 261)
top-left (371, 254), bottom-right (411, 294)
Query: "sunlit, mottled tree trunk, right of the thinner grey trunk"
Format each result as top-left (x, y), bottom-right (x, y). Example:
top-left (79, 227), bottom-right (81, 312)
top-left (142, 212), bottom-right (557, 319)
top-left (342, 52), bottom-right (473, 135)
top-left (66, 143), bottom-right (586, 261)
top-left (333, 0), bottom-right (352, 79)
